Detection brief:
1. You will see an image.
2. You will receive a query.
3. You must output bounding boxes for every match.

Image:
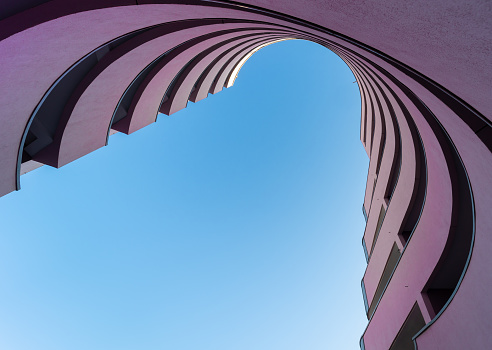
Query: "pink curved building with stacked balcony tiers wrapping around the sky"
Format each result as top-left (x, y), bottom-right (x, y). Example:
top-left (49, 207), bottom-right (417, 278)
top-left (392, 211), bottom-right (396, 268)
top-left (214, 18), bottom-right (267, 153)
top-left (0, 0), bottom-right (492, 350)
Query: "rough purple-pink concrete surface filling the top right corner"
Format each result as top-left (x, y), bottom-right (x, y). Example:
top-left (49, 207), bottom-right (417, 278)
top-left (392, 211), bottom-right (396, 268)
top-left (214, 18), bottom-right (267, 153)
top-left (5, 0), bottom-right (492, 120)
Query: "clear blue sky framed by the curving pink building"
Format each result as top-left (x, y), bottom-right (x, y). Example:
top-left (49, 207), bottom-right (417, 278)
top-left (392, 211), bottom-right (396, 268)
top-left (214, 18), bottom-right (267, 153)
top-left (0, 40), bottom-right (368, 350)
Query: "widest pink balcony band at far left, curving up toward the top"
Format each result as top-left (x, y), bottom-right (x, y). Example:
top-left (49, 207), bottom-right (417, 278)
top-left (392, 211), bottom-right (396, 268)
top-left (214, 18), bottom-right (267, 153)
top-left (0, 5), bottom-right (328, 195)
